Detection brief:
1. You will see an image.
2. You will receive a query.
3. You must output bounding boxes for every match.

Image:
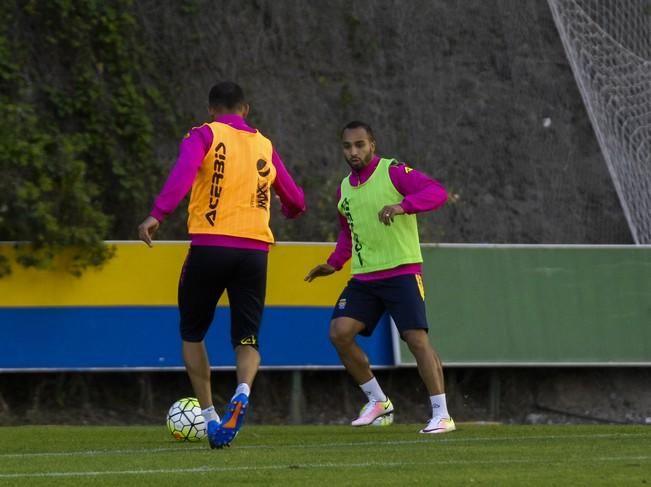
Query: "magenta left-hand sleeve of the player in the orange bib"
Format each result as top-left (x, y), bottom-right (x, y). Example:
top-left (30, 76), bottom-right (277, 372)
top-left (150, 125), bottom-right (212, 221)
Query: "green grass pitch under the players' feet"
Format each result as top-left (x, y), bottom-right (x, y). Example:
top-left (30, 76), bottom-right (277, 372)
top-left (0, 424), bottom-right (651, 487)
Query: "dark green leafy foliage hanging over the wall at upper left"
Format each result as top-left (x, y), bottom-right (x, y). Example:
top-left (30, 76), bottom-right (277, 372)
top-left (0, 0), bottom-right (180, 273)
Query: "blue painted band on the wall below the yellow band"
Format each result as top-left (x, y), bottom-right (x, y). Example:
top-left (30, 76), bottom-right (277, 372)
top-left (0, 306), bottom-right (394, 371)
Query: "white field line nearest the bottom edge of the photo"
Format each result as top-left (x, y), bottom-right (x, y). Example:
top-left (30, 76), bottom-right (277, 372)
top-left (0, 456), bottom-right (651, 480)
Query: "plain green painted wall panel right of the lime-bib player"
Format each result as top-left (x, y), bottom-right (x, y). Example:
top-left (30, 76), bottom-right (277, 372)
top-left (399, 246), bottom-right (651, 365)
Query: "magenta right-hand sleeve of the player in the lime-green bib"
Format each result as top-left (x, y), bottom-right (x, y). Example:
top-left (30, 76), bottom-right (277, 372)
top-left (389, 163), bottom-right (448, 214)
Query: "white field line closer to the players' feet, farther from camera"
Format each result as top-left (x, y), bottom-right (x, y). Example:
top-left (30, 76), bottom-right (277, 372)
top-left (0, 433), bottom-right (648, 462)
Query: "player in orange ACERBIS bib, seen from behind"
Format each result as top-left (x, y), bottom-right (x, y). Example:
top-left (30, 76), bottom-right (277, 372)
top-left (138, 81), bottom-right (305, 448)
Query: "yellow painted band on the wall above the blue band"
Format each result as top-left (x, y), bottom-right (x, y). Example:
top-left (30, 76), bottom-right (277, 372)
top-left (0, 242), bottom-right (350, 307)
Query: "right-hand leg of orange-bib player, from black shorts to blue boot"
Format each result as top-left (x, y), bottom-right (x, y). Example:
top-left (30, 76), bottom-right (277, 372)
top-left (212, 250), bottom-right (267, 447)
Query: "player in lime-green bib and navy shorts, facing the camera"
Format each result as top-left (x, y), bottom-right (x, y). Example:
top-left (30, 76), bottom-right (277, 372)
top-left (305, 121), bottom-right (455, 433)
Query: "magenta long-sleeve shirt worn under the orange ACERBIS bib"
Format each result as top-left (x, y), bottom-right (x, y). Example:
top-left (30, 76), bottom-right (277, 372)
top-left (150, 114), bottom-right (305, 250)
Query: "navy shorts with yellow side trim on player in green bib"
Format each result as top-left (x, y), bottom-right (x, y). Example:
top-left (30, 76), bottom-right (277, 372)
top-left (332, 274), bottom-right (429, 336)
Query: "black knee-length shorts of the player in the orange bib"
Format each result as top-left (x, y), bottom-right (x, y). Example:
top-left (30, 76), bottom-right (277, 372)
top-left (178, 245), bottom-right (268, 348)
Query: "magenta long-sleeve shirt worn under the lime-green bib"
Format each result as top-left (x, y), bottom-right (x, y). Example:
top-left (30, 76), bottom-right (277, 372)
top-left (327, 155), bottom-right (448, 281)
